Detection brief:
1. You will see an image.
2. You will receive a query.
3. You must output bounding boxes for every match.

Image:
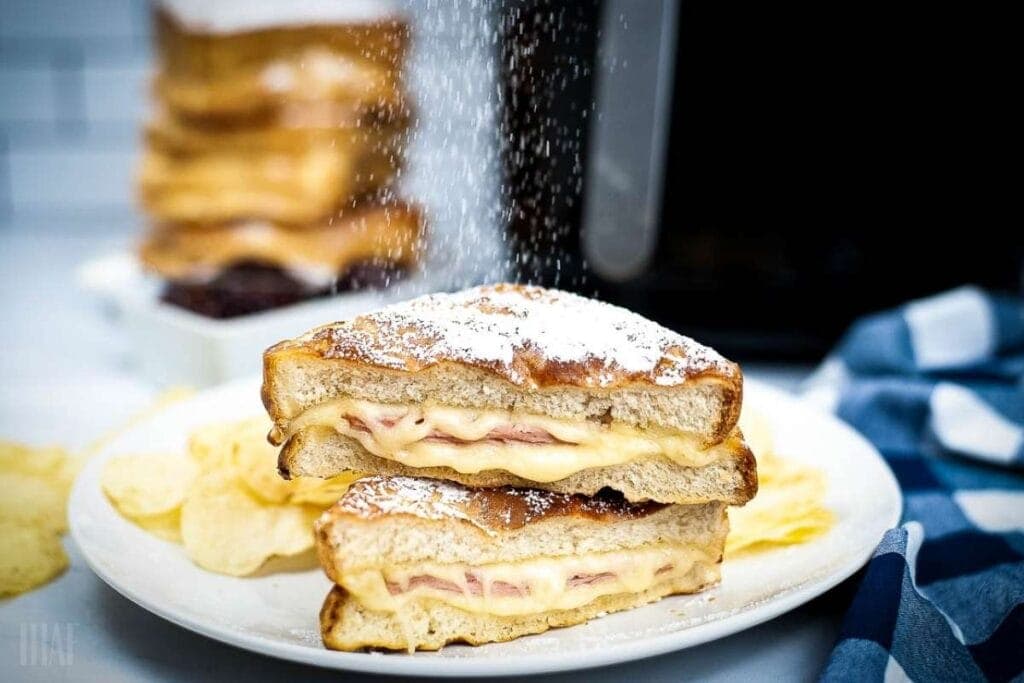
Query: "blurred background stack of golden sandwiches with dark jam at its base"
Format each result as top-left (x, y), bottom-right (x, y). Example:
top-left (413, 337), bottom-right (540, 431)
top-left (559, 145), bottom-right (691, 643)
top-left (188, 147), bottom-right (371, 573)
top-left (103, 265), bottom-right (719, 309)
top-left (139, 0), bottom-right (423, 317)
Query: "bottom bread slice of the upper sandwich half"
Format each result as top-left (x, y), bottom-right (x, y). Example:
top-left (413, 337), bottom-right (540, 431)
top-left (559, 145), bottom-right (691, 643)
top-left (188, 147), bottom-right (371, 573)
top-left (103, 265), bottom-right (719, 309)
top-left (278, 428), bottom-right (758, 505)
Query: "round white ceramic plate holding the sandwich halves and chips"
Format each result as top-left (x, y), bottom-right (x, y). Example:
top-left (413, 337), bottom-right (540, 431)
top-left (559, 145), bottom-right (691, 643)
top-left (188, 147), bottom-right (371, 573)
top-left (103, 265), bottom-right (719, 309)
top-left (70, 381), bottom-right (901, 676)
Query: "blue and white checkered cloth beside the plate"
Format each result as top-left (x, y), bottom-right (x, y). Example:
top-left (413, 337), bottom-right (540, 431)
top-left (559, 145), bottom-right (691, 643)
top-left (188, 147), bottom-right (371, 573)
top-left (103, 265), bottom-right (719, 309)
top-left (807, 288), bottom-right (1024, 681)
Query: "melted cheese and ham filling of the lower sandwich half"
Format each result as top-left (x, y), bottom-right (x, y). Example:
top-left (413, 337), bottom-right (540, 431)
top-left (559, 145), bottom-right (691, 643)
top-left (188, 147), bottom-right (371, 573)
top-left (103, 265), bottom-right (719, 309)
top-left (341, 545), bottom-right (718, 616)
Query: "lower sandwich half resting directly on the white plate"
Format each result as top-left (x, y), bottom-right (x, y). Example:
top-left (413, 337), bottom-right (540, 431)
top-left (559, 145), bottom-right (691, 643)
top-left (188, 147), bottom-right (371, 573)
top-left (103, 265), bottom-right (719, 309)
top-left (315, 477), bottom-right (728, 650)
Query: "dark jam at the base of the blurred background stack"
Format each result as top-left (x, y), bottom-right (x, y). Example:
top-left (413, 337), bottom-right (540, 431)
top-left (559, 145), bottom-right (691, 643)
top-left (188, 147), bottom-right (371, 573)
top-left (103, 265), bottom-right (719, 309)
top-left (160, 263), bottom-right (407, 319)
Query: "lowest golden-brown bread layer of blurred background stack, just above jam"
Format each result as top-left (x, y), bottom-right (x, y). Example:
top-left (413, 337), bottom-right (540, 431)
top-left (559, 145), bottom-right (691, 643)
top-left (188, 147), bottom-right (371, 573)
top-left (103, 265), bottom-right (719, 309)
top-left (140, 204), bottom-right (423, 280)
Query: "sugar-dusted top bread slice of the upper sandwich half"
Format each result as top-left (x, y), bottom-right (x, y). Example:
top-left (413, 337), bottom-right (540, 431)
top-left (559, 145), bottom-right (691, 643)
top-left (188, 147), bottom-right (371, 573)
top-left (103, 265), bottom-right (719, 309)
top-left (262, 285), bottom-right (742, 445)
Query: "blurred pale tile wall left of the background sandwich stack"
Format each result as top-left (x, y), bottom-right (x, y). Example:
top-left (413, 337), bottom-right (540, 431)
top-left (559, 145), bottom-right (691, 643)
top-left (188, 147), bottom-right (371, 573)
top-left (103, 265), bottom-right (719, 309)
top-left (0, 0), bottom-right (150, 232)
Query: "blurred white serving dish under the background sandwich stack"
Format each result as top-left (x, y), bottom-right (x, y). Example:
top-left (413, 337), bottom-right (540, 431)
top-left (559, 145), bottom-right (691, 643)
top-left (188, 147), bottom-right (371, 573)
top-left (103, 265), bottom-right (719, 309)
top-left (78, 251), bottom-right (443, 386)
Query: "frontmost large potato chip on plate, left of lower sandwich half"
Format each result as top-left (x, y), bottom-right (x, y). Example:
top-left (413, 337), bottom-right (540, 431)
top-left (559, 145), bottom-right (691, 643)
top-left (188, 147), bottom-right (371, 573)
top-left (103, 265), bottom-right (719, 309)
top-left (181, 472), bottom-right (317, 577)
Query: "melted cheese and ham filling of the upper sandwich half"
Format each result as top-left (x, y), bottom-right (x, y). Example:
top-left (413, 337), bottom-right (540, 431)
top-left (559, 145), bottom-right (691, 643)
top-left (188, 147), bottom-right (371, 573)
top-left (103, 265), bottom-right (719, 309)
top-left (287, 398), bottom-right (740, 482)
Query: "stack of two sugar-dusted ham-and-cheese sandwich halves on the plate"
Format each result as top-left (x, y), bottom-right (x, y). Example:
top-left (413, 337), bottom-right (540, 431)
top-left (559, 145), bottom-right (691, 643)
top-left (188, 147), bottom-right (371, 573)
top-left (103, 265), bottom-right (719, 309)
top-left (263, 285), bottom-right (757, 650)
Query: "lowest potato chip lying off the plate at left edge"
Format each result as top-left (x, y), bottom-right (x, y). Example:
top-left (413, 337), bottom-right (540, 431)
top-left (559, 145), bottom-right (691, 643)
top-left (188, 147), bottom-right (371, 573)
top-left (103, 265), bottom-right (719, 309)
top-left (0, 519), bottom-right (68, 596)
